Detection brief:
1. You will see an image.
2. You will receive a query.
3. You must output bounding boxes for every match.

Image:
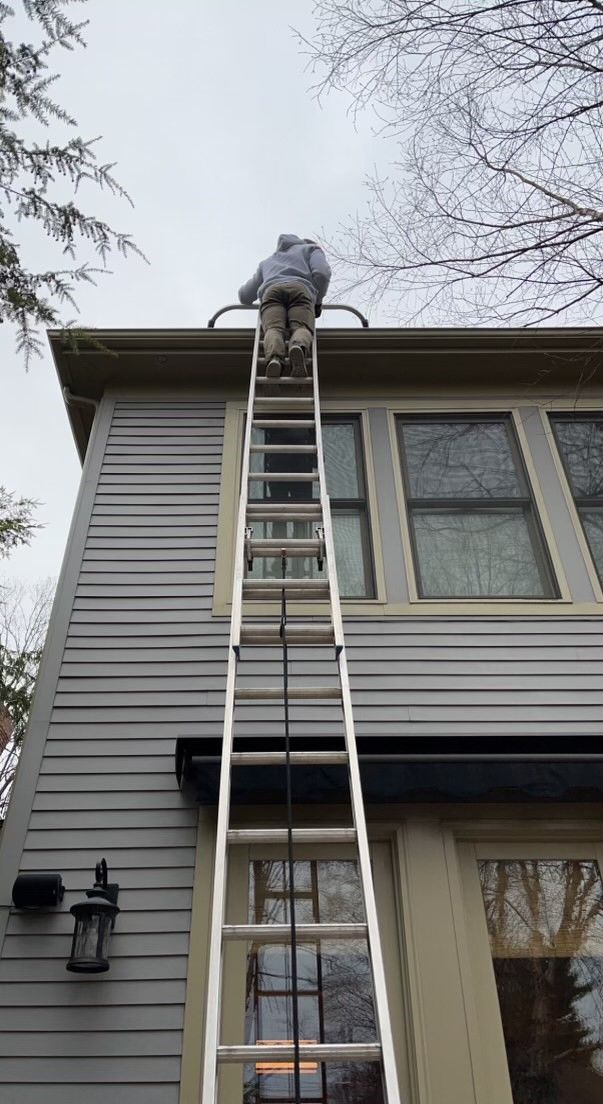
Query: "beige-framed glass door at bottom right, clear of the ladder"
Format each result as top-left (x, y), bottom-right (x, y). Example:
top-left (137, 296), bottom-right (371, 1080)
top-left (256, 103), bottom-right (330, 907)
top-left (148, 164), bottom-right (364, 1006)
top-left (455, 821), bottom-right (603, 1104)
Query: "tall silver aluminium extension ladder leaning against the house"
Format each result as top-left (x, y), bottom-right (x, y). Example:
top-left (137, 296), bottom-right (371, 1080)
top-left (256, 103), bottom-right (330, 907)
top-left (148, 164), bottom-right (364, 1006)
top-left (201, 307), bottom-right (401, 1104)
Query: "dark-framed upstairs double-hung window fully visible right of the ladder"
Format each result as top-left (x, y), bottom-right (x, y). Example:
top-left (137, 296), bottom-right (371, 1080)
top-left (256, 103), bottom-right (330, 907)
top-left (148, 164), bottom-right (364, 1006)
top-left (398, 415), bottom-right (558, 598)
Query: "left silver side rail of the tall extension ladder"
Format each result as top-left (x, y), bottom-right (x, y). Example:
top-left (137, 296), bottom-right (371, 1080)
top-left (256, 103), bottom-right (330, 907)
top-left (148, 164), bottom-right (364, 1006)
top-left (201, 312), bottom-right (261, 1104)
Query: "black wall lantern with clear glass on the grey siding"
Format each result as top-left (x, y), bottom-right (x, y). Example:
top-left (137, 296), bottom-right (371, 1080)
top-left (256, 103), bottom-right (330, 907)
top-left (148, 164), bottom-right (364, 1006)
top-left (66, 859), bottom-right (119, 974)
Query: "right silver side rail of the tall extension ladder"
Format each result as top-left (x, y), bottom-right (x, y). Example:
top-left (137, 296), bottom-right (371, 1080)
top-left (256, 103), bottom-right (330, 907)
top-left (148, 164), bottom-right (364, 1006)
top-left (313, 332), bottom-right (401, 1104)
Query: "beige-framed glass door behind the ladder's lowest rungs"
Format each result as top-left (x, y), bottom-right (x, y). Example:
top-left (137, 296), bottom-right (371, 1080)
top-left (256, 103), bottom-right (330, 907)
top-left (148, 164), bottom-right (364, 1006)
top-left (206, 834), bottom-right (411, 1104)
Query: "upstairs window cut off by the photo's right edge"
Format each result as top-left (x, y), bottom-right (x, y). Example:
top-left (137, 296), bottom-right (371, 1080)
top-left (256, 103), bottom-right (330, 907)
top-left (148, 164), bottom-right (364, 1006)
top-left (551, 414), bottom-right (603, 583)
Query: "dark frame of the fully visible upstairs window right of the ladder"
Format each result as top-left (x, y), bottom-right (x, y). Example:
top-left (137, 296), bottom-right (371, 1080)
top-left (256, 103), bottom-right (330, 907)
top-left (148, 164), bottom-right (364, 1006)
top-left (393, 407), bottom-right (558, 605)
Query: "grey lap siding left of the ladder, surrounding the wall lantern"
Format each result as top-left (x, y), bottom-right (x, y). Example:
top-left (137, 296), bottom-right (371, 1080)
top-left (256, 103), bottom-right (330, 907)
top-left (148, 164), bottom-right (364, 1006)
top-left (0, 402), bottom-right (228, 1104)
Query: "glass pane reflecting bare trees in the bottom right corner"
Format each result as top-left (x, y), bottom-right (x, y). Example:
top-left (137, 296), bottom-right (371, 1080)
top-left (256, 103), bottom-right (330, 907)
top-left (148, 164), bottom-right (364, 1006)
top-left (479, 860), bottom-right (603, 1104)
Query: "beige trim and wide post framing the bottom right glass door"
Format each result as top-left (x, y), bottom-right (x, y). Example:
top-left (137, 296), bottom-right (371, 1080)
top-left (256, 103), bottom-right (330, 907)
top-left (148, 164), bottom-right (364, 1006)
top-left (392, 805), bottom-right (603, 1104)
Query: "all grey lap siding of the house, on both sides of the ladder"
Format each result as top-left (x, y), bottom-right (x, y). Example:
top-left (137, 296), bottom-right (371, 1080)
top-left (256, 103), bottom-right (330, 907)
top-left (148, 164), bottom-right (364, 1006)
top-left (0, 399), bottom-right (603, 1104)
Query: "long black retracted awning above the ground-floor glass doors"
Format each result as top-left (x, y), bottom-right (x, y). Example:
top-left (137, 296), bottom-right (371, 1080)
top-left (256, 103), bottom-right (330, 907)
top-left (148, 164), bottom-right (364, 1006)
top-left (176, 734), bottom-right (603, 805)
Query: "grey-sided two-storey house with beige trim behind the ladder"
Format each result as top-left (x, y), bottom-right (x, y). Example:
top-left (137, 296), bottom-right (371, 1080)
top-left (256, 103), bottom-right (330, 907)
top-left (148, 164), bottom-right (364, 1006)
top-left (0, 327), bottom-right (603, 1104)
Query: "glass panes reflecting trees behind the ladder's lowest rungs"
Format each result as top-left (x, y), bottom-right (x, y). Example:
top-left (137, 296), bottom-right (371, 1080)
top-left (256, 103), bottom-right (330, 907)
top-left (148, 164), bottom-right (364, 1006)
top-left (244, 860), bottom-right (383, 1104)
